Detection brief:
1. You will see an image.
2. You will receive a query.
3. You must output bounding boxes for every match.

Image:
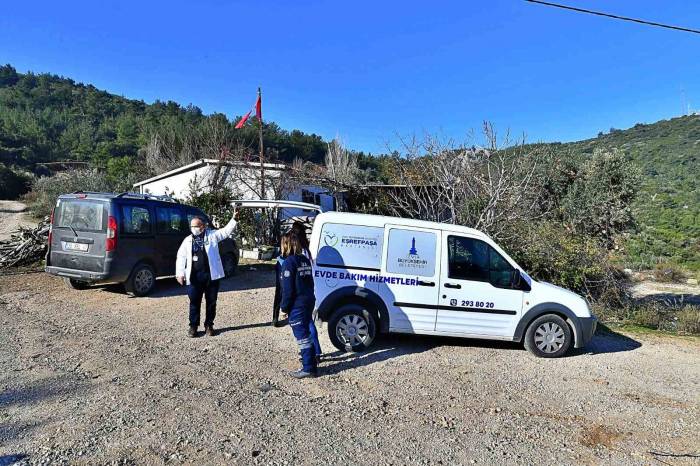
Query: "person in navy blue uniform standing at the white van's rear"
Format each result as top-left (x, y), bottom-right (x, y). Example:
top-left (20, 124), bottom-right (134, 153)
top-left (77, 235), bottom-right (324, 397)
top-left (280, 232), bottom-right (318, 379)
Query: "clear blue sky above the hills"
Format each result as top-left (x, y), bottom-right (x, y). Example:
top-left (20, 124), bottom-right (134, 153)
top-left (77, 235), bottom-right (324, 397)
top-left (0, 0), bottom-right (700, 153)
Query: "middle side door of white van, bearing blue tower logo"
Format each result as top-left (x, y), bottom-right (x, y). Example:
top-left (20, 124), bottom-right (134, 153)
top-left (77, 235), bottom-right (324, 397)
top-left (378, 225), bottom-right (441, 333)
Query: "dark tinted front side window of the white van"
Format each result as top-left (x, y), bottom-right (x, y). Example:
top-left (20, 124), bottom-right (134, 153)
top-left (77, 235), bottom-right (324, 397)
top-left (447, 236), bottom-right (513, 288)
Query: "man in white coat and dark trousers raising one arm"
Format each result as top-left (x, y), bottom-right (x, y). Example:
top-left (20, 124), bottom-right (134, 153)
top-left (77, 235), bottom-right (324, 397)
top-left (175, 211), bottom-right (238, 337)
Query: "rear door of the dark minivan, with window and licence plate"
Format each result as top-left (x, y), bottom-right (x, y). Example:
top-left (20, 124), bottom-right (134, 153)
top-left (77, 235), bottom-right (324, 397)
top-left (49, 198), bottom-right (109, 272)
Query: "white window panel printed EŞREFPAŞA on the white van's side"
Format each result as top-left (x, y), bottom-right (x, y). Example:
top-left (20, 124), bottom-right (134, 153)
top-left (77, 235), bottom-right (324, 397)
top-left (316, 223), bottom-right (384, 271)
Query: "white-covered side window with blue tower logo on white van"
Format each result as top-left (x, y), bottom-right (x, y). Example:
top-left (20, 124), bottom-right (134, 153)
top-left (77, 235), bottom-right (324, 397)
top-left (386, 228), bottom-right (437, 277)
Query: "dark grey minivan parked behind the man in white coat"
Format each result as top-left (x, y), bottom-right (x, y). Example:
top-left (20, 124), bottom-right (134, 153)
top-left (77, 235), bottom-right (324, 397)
top-left (46, 191), bottom-right (238, 296)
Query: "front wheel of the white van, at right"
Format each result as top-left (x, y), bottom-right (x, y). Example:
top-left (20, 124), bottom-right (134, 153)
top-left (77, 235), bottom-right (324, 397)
top-left (525, 314), bottom-right (573, 358)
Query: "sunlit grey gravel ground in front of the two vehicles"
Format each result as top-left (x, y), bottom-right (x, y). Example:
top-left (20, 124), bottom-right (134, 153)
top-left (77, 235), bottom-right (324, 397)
top-left (0, 268), bottom-right (700, 465)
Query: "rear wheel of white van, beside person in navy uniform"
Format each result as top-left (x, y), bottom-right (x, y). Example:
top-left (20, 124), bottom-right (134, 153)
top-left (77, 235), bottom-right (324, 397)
top-left (328, 304), bottom-right (377, 353)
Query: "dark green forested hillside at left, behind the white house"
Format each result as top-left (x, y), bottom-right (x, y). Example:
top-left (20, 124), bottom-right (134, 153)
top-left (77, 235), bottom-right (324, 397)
top-left (0, 65), bottom-right (340, 178)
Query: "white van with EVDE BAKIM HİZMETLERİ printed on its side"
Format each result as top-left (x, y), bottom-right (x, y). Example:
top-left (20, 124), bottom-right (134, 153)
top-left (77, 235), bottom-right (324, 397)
top-left (311, 212), bottom-right (596, 358)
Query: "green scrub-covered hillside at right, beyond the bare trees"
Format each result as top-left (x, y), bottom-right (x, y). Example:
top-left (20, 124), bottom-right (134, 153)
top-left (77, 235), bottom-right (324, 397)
top-left (555, 115), bottom-right (700, 270)
